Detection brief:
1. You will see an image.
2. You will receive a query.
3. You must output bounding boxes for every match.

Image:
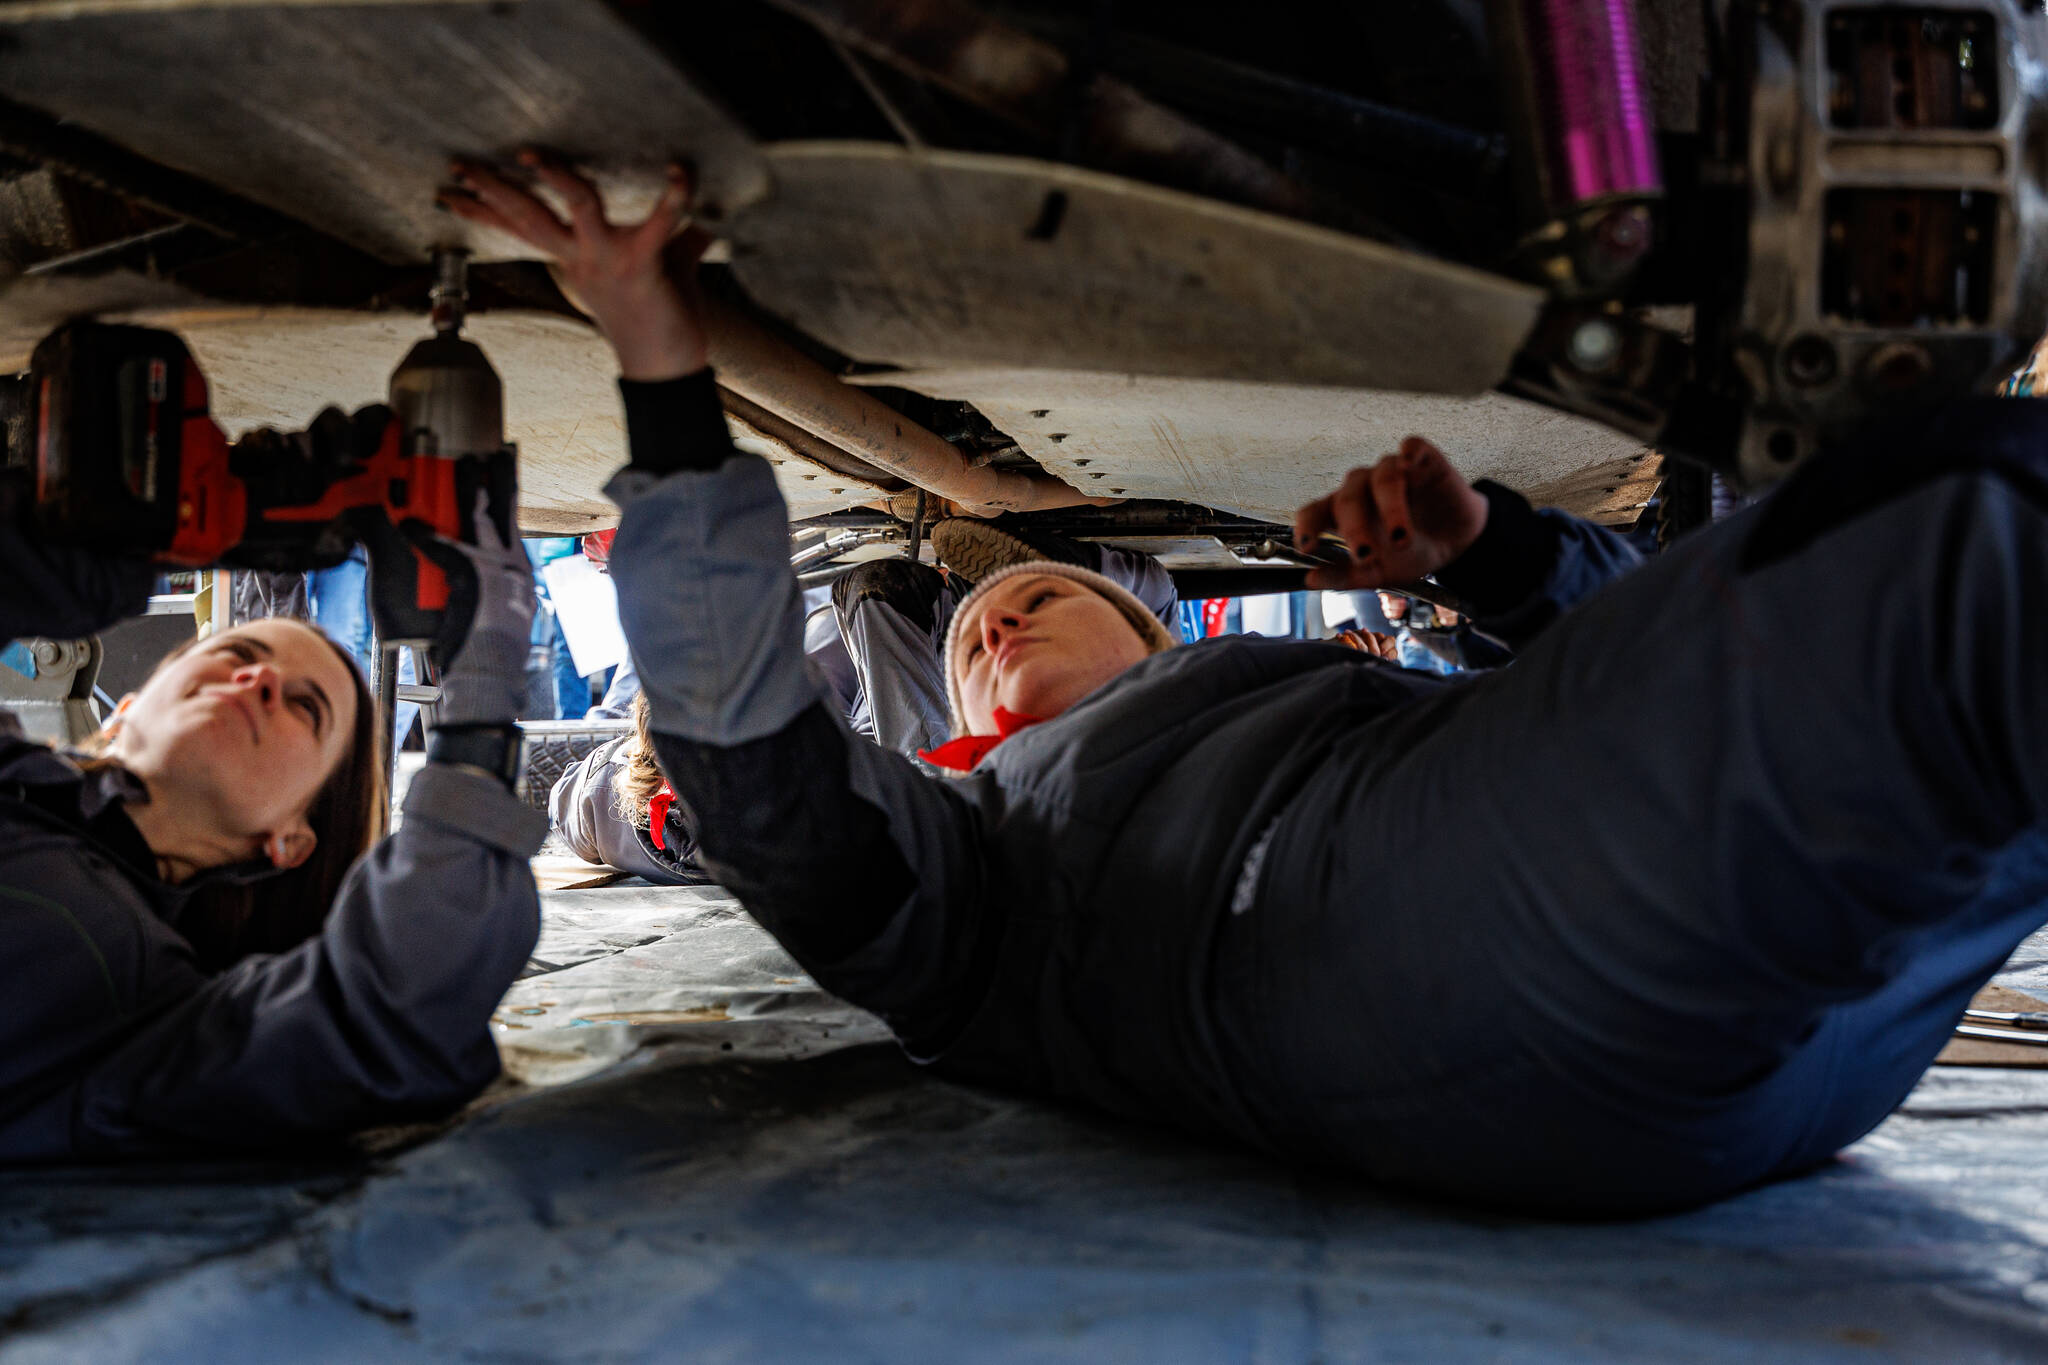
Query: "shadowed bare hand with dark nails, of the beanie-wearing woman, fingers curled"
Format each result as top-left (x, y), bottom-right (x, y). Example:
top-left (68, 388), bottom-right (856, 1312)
top-left (1294, 436), bottom-right (1487, 589)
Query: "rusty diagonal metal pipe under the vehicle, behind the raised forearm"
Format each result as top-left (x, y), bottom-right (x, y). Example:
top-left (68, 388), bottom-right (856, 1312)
top-left (705, 299), bottom-right (1118, 516)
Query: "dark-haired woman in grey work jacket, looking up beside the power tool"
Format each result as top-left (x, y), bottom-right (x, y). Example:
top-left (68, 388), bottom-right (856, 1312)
top-left (0, 474), bottom-right (545, 1160)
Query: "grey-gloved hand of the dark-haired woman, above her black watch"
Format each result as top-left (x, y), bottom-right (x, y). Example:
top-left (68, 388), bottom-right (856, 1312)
top-left (412, 470), bottom-right (535, 729)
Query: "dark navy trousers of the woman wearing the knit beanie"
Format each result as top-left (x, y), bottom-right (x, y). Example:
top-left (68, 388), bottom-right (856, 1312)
top-left (1217, 429), bottom-right (2048, 1216)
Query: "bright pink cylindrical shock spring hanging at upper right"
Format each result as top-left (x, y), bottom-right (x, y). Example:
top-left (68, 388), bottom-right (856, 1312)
top-left (1522, 0), bottom-right (1663, 211)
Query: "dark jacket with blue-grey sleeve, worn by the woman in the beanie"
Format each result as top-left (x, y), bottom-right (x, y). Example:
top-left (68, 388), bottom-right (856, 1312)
top-left (608, 372), bottom-right (1638, 1142)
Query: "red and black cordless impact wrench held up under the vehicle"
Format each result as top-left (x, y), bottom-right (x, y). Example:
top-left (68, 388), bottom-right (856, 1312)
top-left (8, 304), bottom-right (516, 663)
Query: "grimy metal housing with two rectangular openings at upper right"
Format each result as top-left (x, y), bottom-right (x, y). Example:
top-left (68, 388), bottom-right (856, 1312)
top-left (1702, 0), bottom-right (2048, 487)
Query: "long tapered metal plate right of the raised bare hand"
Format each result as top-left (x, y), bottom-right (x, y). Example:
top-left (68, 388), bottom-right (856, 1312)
top-left (729, 141), bottom-right (1542, 393)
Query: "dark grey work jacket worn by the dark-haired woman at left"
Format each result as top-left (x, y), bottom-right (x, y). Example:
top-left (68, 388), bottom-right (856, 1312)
top-left (0, 516), bottom-right (547, 1160)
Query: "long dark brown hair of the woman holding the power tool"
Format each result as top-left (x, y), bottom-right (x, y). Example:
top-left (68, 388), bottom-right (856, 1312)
top-left (80, 620), bottom-right (389, 972)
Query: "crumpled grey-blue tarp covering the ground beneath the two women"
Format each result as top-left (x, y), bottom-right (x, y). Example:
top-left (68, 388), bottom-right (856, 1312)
top-left (12, 888), bottom-right (2048, 1365)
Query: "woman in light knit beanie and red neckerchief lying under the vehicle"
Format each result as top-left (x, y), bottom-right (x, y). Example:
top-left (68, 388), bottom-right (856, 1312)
top-left (457, 154), bottom-right (2048, 1216)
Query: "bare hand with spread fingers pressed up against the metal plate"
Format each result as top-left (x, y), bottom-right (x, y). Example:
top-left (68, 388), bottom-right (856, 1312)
top-left (438, 147), bottom-right (711, 381)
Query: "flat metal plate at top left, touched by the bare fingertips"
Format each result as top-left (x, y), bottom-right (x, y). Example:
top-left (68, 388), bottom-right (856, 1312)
top-left (0, 0), bottom-right (766, 262)
